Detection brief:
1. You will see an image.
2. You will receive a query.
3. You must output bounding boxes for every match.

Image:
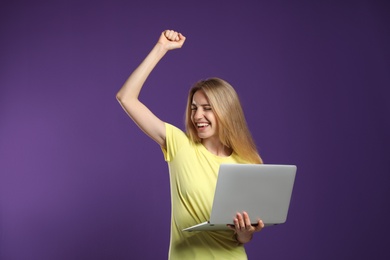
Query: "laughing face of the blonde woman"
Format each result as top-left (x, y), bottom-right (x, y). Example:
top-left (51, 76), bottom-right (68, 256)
top-left (191, 90), bottom-right (218, 139)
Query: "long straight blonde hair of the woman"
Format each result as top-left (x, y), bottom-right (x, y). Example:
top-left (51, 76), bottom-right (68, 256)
top-left (185, 78), bottom-right (263, 163)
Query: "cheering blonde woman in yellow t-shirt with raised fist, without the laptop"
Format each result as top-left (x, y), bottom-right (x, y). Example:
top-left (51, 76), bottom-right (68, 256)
top-left (117, 30), bottom-right (264, 260)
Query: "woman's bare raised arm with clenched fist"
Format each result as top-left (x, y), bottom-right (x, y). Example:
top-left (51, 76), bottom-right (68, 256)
top-left (116, 30), bottom-right (186, 147)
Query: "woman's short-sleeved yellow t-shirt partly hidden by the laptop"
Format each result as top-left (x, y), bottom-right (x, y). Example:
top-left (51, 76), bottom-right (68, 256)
top-left (162, 124), bottom-right (247, 260)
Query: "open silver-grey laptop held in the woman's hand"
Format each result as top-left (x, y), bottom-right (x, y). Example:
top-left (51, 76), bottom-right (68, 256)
top-left (183, 164), bottom-right (297, 231)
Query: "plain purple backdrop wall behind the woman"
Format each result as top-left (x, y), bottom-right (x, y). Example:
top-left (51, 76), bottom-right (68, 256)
top-left (0, 0), bottom-right (390, 260)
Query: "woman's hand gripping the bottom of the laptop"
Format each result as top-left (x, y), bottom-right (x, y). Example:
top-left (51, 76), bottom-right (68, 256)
top-left (229, 211), bottom-right (264, 244)
